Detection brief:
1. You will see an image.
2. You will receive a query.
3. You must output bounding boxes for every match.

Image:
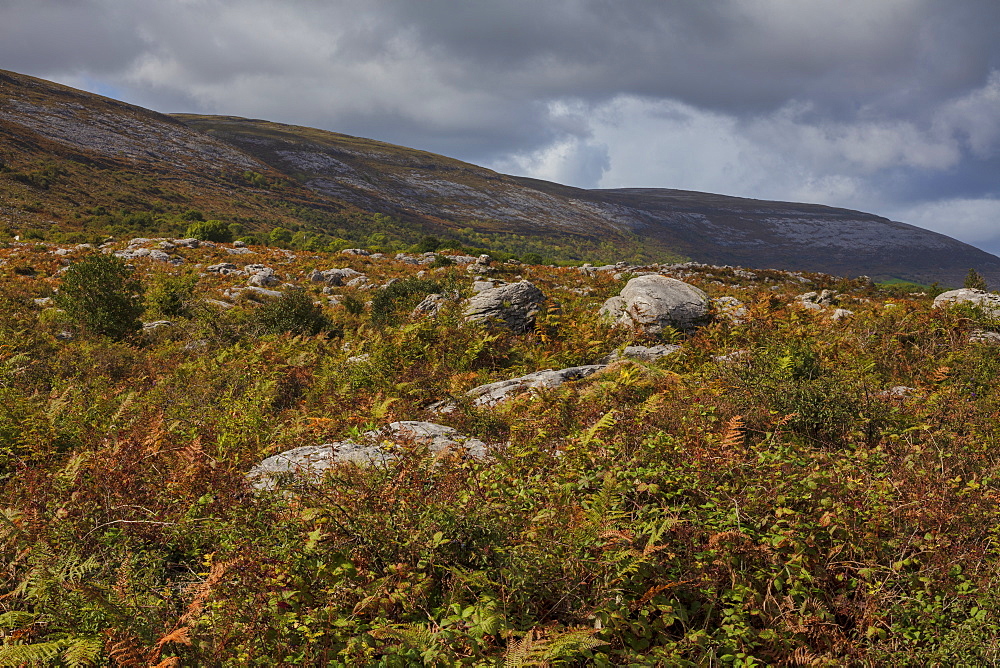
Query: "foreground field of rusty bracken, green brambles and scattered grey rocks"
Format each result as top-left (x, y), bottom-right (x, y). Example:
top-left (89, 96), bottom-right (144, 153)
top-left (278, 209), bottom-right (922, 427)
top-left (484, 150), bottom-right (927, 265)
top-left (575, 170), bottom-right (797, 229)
top-left (0, 238), bottom-right (1000, 666)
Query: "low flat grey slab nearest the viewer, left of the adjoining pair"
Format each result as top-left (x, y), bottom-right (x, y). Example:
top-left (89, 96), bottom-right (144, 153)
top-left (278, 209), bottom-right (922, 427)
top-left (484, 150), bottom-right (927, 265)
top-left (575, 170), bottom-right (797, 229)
top-left (246, 441), bottom-right (395, 490)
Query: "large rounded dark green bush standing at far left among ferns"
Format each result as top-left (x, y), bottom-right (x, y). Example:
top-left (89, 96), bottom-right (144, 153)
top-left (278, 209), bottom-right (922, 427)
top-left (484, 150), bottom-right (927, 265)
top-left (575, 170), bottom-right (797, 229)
top-left (55, 254), bottom-right (143, 340)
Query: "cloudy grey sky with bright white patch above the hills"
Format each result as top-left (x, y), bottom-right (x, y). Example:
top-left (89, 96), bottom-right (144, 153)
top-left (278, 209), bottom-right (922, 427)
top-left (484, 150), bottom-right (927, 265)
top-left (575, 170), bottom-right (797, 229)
top-left (0, 0), bottom-right (1000, 253)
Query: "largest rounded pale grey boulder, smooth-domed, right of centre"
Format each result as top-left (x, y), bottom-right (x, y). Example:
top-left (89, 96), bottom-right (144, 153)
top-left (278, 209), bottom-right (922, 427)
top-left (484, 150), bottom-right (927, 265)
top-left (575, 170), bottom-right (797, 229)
top-left (600, 274), bottom-right (708, 334)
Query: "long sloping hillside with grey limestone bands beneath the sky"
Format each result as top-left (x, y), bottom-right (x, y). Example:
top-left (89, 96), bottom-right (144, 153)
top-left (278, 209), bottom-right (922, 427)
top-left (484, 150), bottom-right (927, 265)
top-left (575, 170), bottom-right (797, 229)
top-left (0, 72), bottom-right (1000, 285)
